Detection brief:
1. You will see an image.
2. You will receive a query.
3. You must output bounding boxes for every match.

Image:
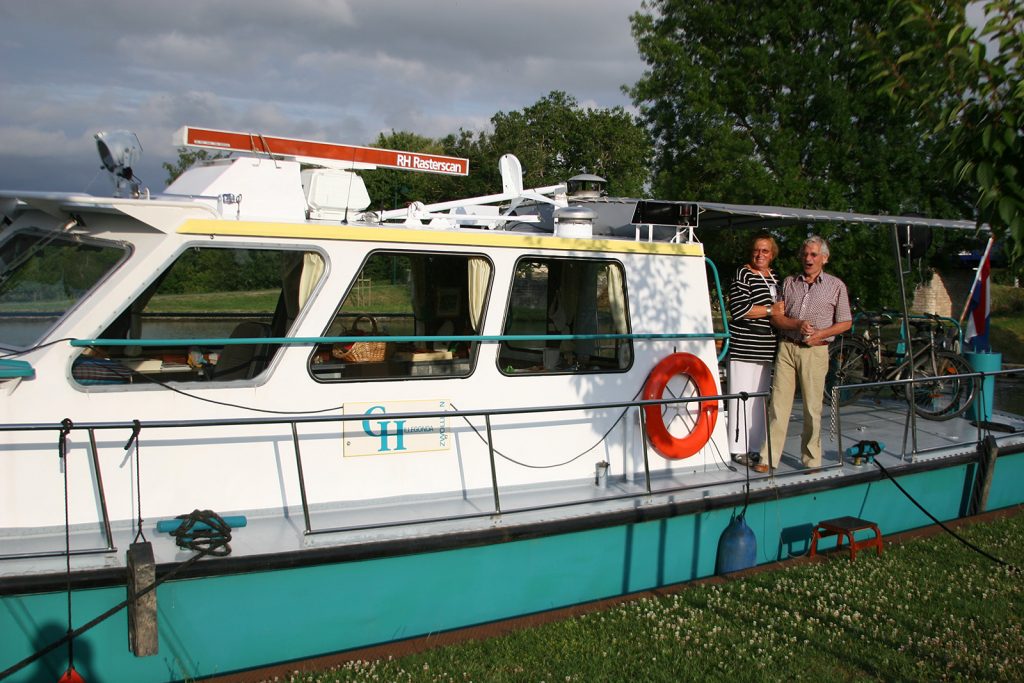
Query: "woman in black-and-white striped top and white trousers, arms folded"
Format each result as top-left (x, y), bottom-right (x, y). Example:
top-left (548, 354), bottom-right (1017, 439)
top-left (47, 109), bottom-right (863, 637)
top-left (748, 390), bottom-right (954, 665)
top-left (728, 232), bottom-right (781, 472)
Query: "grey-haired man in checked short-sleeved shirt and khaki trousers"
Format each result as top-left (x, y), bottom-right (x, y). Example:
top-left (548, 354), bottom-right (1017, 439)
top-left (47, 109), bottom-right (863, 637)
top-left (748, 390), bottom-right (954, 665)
top-left (755, 234), bottom-right (853, 474)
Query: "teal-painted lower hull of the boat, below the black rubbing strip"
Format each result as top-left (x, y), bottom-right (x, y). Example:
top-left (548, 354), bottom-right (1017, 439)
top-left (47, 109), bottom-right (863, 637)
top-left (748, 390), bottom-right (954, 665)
top-left (0, 456), bottom-right (1024, 683)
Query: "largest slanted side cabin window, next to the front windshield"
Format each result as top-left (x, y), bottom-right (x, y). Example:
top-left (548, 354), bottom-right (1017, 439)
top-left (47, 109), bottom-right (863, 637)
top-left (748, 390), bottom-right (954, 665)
top-left (72, 247), bottom-right (324, 385)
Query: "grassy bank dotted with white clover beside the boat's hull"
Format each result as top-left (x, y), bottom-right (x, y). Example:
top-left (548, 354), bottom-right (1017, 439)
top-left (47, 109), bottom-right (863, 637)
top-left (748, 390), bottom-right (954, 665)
top-left (266, 514), bottom-right (1024, 683)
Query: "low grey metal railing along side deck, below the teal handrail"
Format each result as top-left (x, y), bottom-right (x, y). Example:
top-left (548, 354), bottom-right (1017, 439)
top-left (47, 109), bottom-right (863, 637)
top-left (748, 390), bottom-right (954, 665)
top-left (0, 392), bottom-right (768, 559)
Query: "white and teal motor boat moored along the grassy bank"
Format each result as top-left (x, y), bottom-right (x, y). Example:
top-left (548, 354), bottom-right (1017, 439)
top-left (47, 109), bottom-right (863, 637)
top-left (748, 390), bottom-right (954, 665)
top-left (0, 127), bottom-right (1024, 682)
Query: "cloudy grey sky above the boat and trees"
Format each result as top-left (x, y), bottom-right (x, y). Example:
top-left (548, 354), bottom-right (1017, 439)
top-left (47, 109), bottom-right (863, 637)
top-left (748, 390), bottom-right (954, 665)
top-left (0, 0), bottom-right (644, 195)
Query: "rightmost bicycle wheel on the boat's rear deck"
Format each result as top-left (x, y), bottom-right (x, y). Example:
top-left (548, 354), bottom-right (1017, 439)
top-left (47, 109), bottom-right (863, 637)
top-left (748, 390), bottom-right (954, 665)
top-left (906, 351), bottom-right (975, 420)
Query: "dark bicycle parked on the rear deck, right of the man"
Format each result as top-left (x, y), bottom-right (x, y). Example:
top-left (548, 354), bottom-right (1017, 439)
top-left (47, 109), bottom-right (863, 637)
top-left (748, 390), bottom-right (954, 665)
top-left (824, 311), bottom-right (977, 420)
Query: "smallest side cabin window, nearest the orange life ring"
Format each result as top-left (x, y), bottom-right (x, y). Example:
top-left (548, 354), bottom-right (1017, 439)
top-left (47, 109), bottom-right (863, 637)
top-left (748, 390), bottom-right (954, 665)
top-left (498, 258), bottom-right (633, 375)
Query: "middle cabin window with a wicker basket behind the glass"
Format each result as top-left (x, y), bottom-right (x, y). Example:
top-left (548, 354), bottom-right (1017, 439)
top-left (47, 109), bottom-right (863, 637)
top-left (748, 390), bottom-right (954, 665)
top-left (309, 252), bottom-right (492, 382)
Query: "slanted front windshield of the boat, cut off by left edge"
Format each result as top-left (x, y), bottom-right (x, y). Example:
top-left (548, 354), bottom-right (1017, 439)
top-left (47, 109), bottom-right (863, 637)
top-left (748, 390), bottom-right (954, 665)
top-left (0, 232), bottom-right (128, 350)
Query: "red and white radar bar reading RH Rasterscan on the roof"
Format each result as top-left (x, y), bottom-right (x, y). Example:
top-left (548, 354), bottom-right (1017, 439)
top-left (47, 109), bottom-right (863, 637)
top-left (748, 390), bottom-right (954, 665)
top-left (174, 126), bottom-right (469, 175)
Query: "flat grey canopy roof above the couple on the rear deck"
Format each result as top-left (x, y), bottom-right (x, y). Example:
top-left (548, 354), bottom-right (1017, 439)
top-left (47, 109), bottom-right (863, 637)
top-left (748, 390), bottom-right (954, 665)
top-left (697, 202), bottom-right (989, 232)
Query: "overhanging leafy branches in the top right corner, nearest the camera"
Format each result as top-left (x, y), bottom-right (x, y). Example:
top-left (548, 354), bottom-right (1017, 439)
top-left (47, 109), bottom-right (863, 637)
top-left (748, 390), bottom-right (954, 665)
top-left (867, 0), bottom-right (1024, 261)
